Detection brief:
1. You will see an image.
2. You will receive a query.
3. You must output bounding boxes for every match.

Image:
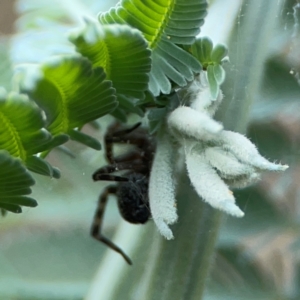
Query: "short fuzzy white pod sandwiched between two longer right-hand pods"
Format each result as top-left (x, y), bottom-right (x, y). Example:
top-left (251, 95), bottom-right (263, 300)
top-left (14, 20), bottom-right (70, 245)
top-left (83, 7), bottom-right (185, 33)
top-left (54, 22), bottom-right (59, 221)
top-left (205, 147), bottom-right (254, 178)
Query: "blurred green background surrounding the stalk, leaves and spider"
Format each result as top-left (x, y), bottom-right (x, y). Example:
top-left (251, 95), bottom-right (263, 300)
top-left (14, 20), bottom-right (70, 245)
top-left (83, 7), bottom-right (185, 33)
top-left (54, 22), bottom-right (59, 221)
top-left (0, 0), bottom-right (300, 300)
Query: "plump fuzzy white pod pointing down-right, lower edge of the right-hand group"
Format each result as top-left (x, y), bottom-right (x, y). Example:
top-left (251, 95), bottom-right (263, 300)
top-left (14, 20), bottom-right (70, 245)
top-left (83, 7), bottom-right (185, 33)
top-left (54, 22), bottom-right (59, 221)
top-left (186, 152), bottom-right (244, 217)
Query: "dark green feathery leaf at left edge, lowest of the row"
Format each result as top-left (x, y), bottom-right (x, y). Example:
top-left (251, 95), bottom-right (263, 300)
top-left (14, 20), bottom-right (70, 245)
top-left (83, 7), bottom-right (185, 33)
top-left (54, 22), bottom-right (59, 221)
top-left (0, 150), bottom-right (37, 213)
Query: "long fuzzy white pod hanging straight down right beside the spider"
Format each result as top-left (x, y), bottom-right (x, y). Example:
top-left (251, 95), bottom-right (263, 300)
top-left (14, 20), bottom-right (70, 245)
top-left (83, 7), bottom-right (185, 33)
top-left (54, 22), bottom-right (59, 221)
top-left (149, 131), bottom-right (178, 239)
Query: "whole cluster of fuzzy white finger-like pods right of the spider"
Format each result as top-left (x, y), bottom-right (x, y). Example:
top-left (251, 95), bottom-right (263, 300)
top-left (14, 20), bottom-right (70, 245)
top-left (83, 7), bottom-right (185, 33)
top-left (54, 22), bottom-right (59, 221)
top-left (149, 72), bottom-right (288, 239)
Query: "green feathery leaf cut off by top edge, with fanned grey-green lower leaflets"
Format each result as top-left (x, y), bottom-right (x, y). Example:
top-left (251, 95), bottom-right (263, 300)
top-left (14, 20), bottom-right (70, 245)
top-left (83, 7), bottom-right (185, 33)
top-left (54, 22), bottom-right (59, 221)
top-left (99, 0), bottom-right (207, 96)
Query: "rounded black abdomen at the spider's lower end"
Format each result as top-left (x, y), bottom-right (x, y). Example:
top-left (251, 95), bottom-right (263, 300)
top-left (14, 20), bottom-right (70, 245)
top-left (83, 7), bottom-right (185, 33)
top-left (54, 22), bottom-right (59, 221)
top-left (118, 173), bottom-right (151, 224)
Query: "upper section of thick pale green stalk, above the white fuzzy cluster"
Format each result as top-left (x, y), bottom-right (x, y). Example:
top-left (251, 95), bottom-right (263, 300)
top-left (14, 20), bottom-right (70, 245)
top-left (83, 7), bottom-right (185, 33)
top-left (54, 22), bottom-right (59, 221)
top-left (217, 0), bottom-right (284, 133)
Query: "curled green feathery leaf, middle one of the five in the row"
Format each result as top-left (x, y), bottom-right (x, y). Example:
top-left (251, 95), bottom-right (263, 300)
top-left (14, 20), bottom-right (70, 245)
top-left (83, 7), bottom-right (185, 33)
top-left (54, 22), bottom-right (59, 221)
top-left (21, 55), bottom-right (118, 149)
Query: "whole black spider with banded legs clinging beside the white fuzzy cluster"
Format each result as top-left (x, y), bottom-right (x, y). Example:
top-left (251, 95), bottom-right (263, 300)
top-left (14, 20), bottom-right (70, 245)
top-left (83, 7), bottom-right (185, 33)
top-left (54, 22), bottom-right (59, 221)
top-left (91, 123), bottom-right (155, 265)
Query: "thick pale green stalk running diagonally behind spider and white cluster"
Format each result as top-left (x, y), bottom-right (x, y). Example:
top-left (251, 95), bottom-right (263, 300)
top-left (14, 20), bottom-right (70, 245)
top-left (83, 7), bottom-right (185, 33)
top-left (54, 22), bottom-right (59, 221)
top-left (86, 0), bottom-right (283, 300)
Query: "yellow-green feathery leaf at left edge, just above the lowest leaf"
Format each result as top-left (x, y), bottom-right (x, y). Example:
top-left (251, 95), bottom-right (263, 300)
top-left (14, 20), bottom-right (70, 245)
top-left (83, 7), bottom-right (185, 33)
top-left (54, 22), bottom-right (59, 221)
top-left (0, 89), bottom-right (62, 177)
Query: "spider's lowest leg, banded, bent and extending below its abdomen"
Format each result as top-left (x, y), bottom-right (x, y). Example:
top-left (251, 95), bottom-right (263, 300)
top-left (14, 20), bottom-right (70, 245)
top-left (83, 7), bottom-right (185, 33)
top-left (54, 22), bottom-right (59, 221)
top-left (91, 185), bottom-right (132, 265)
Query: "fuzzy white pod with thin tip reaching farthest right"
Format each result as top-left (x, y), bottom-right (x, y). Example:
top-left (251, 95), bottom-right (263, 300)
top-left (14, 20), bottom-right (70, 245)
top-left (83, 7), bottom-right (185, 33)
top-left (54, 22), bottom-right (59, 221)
top-left (220, 130), bottom-right (288, 171)
